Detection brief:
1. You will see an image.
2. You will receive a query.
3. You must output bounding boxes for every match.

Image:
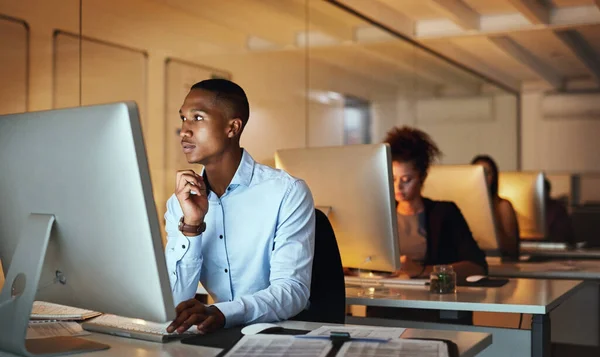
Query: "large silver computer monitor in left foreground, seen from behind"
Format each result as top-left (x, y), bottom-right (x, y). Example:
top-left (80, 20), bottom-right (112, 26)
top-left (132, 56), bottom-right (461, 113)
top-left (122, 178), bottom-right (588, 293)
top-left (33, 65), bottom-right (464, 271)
top-left (0, 103), bottom-right (175, 355)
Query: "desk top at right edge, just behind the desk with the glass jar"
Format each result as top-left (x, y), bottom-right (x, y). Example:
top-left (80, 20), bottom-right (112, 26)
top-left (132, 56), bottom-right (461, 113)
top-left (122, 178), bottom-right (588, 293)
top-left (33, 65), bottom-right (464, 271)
top-left (489, 260), bottom-right (600, 280)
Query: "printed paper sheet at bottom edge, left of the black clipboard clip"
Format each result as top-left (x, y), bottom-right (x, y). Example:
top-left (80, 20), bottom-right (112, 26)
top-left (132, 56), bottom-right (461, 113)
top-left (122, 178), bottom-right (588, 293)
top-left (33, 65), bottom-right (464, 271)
top-left (225, 335), bottom-right (332, 357)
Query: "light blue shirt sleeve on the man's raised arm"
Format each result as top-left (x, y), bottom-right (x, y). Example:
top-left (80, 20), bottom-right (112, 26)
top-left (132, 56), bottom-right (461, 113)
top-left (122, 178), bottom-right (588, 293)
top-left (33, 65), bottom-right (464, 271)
top-left (165, 195), bottom-right (203, 306)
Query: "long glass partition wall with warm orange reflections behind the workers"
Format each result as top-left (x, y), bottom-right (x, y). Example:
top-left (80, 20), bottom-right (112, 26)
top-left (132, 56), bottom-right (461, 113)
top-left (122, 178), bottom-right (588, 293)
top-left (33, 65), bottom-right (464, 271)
top-left (0, 0), bottom-right (518, 239)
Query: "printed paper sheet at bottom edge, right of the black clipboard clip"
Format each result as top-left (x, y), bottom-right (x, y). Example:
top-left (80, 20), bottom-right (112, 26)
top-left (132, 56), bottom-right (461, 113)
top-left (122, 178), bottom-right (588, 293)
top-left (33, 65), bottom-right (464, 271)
top-left (336, 338), bottom-right (449, 357)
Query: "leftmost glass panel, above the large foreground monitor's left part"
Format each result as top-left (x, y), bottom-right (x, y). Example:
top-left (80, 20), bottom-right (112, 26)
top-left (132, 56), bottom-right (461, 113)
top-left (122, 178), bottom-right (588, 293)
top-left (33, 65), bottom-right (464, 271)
top-left (0, 0), bottom-right (80, 114)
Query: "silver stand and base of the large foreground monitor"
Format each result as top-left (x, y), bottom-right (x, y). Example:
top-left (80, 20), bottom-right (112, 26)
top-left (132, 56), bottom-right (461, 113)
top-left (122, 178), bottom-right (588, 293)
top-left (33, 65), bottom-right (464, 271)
top-left (0, 214), bottom-right (110, 357)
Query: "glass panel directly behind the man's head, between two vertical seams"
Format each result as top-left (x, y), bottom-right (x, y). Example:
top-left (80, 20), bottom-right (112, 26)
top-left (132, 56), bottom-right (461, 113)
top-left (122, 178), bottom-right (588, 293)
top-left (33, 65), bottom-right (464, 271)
top-left (82, 0), bottom-right (310, 239)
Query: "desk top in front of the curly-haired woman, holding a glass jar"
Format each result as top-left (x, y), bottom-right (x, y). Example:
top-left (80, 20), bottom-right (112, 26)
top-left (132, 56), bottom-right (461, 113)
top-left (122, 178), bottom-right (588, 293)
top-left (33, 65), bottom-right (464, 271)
top-left (346, 279), bottom-right (583, 314)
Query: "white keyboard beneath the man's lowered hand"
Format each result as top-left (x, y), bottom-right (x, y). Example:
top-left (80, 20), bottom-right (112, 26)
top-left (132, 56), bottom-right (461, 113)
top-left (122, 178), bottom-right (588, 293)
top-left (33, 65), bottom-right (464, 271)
top-left (81, 314), bottom-right (198, 343)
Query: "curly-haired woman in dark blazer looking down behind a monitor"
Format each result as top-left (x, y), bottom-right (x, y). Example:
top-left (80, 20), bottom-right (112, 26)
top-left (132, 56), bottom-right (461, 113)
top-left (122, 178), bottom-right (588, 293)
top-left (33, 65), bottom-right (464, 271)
top-left (385, 127), bottom-right (487, 281)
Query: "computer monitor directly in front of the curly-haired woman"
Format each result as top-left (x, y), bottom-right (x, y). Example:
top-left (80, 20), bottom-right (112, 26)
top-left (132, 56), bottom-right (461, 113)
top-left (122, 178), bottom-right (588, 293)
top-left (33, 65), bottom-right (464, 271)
top-left (275, 144), bottom-right (400, 272)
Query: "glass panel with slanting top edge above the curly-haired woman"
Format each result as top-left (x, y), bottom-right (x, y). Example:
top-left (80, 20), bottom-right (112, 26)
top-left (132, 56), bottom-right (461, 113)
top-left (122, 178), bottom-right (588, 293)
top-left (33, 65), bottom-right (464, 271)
top-left (305, 1), bottom-right (518, 170)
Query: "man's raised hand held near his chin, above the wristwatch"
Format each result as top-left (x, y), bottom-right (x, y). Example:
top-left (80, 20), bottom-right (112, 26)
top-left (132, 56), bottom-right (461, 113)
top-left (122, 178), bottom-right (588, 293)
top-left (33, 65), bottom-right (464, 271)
top-left (175, 170), bottom-right (208, 226)
